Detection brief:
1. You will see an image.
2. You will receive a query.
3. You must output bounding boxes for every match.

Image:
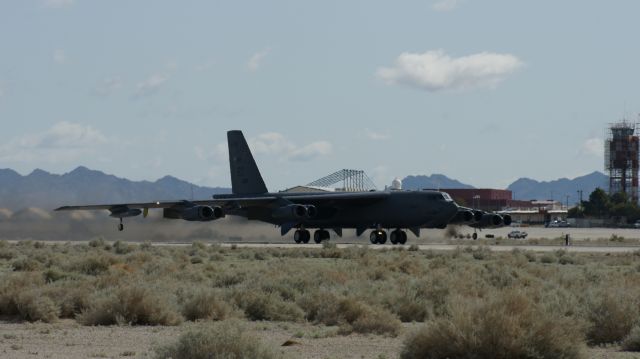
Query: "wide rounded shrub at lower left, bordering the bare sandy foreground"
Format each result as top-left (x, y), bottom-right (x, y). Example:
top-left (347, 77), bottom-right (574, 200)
top-left (77, 283), bottom-right (182, 325)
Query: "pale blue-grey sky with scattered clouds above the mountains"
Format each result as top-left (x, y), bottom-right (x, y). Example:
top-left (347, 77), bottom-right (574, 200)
top-left (0, 0), bottom-right (640, 191)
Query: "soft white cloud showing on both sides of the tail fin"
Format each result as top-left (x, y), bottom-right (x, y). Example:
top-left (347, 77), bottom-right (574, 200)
top-left (204, 132), bottom-right (333, 165)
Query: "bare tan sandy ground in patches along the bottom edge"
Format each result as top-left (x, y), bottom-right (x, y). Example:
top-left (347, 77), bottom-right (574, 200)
top-left (0, 320), bottom-right (640, 359)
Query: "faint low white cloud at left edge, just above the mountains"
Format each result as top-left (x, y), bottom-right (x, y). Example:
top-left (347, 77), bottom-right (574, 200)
top-left (0, 121), bottom-right (109, 163)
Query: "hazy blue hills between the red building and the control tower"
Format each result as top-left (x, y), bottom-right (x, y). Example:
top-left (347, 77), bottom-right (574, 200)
top-left (507, 171), bottom-right (609, 205)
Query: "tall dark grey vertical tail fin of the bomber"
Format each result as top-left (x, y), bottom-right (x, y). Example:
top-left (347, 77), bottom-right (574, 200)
top-left (227, 130), bottom-right (267, 194)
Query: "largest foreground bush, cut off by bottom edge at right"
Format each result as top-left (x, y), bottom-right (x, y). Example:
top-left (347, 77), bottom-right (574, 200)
top-left (400, 292), bottom-right (582, 359)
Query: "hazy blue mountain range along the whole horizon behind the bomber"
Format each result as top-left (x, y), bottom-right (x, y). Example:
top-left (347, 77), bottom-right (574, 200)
top-left (0, 166), bottom-right (608, 211)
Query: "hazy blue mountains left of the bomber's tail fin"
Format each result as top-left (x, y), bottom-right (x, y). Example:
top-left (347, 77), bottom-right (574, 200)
top-left (0, 166), bottom-right (231, 211)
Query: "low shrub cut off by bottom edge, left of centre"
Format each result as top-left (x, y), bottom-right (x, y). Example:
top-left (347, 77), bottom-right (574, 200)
top-left (155, 323), bottom-right (280, 359)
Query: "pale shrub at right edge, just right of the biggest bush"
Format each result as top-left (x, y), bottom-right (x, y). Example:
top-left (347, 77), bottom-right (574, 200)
top-left (587, 289), bottom-right (639, 344)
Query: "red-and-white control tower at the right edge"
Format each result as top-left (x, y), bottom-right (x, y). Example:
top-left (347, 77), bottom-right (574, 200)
top-left (604, 121), bottom-right (639, 203)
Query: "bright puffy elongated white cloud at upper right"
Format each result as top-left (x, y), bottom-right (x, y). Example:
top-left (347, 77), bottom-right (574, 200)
top-left (376, 50), bottom-right (523, 92)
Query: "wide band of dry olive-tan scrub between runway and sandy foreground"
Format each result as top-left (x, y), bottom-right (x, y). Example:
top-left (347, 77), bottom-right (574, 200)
top-left (0, 239), bottom-right (640, 357)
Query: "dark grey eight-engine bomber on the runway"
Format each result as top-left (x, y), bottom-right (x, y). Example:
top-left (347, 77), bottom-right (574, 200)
top-left (56, 131), bottom-right (511, 244)
